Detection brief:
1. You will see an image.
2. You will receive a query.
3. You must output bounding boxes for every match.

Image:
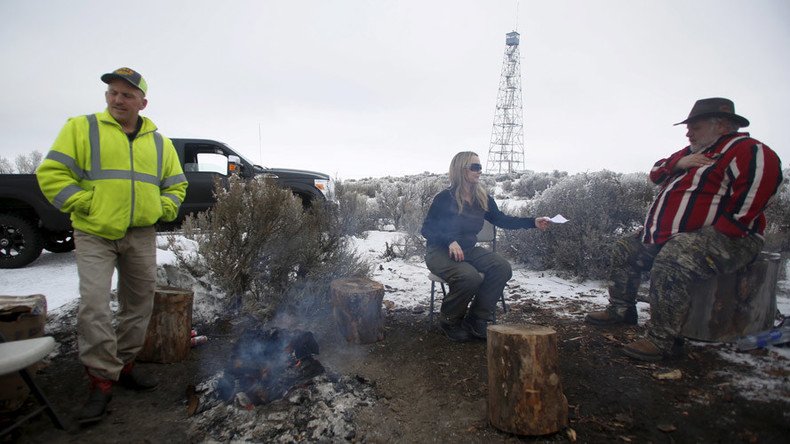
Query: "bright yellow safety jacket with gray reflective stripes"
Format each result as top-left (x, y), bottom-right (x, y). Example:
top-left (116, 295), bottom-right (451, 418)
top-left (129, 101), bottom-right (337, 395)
top-left (36, 110), bottom-right (187, 240)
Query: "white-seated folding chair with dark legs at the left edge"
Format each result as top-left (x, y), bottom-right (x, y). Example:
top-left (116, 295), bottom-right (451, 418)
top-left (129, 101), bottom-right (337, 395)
top-left (0, 335), bottom-right (65, 436)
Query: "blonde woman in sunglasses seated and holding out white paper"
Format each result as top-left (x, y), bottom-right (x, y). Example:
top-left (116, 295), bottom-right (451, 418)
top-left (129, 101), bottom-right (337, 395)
top-left (421, 151), bottom-right (551, 342)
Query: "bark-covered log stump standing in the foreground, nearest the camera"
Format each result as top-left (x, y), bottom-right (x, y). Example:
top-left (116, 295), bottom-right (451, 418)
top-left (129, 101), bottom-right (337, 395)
top-left (487, 324), bottom-right (568, 435)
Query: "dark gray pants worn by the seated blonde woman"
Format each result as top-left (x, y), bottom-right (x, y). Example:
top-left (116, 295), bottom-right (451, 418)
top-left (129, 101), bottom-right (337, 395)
top-left (425, 247), bottom-right (513, 323)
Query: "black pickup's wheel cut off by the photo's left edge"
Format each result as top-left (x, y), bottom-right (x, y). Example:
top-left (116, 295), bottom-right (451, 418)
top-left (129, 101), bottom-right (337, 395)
top-left (0, 214), bottom-right (43, 268)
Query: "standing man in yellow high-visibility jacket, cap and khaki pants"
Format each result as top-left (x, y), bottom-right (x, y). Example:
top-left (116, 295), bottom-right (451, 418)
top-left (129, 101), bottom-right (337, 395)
top-left (36, 68), bottom-right (187, 424)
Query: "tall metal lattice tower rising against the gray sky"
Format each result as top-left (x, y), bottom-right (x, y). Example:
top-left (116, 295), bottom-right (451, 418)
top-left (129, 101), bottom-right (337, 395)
top-left (486, 31), bottom-right (524, 173)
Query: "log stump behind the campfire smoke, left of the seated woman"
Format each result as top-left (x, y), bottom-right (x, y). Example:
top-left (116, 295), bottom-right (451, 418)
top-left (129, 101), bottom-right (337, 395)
top-left (330, 278), bottom-right (384, 344)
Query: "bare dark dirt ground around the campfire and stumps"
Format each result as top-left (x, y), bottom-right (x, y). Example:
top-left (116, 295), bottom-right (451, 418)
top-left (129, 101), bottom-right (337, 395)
top-left (0, 296), bottom-right (790, 443)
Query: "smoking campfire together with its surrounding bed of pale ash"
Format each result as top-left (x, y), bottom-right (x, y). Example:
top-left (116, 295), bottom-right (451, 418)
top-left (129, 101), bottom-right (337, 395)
top-left (187, 328), bottom-right (376, 442)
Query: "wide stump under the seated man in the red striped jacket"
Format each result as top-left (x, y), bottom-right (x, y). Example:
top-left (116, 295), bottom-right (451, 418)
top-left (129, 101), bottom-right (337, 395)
top-left (681, 251), bottom-right (781, 342)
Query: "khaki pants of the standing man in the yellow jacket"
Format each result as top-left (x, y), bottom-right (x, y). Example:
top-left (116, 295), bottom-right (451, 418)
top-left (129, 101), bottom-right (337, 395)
top-left (74, 227), bottom-right (156, 381)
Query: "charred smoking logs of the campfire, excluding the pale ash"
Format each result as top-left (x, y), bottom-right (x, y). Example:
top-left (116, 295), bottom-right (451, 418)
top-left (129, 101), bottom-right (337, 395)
top-left (217, 328), bottom-right (324, 408)
